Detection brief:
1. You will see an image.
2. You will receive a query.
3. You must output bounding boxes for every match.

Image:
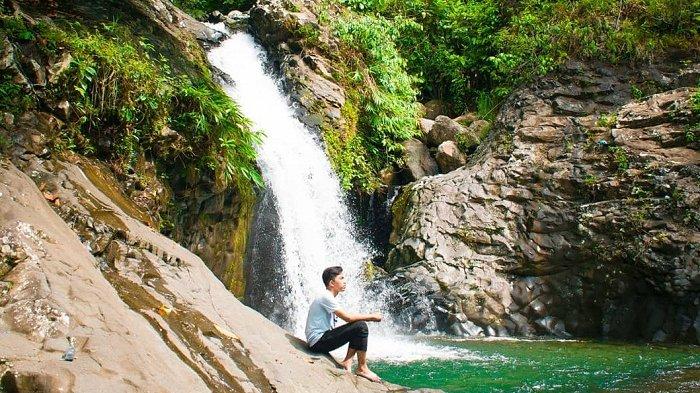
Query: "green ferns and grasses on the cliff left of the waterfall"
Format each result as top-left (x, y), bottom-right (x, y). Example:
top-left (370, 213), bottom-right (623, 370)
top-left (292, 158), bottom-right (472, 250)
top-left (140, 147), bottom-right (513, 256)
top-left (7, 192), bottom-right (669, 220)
top-left (29, 19), bottom-right (261, 188)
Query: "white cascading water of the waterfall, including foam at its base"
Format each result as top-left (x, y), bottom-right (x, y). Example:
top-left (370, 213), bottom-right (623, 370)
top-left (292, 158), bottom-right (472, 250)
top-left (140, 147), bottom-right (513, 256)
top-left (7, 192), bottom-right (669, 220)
top-left (208, 25), bottom-right (469, 360)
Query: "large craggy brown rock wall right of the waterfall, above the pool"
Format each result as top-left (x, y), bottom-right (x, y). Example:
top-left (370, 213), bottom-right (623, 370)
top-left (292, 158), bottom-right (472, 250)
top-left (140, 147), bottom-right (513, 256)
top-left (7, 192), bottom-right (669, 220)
top-left (387, 63), bottom-right (700, 343)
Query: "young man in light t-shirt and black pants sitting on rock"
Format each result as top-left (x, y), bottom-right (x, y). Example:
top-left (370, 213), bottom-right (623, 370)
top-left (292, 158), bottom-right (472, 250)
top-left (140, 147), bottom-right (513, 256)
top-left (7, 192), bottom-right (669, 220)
top-left (306, 266), bottom-right (382, 382)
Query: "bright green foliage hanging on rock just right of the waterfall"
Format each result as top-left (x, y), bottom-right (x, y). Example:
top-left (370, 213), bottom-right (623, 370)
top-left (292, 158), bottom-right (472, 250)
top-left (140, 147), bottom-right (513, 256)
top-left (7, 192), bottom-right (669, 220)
top-left (326, 13), bottom-right (419, 189)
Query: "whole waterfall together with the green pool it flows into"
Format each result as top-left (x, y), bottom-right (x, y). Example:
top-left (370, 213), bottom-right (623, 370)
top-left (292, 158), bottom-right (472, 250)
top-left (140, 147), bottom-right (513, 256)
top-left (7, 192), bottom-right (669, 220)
top-left (204, 25), bottom-right (700, 392)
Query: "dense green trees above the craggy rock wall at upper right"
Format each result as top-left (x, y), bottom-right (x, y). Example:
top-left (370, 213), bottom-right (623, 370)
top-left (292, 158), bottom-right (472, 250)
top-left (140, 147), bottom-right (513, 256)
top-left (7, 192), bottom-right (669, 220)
top-left (340, 0), bottom-right (700, 112)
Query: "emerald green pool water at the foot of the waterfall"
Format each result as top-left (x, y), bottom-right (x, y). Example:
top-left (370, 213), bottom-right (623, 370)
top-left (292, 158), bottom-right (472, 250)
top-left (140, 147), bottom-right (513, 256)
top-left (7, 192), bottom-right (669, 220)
top-left (370, 339), bottom-right (700, 393)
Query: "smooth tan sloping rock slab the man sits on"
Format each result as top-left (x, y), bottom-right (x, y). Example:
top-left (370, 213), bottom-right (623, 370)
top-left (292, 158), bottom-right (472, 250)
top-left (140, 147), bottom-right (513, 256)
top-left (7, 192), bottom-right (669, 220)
top-left (0, 114), bottom-right (401, 392)
